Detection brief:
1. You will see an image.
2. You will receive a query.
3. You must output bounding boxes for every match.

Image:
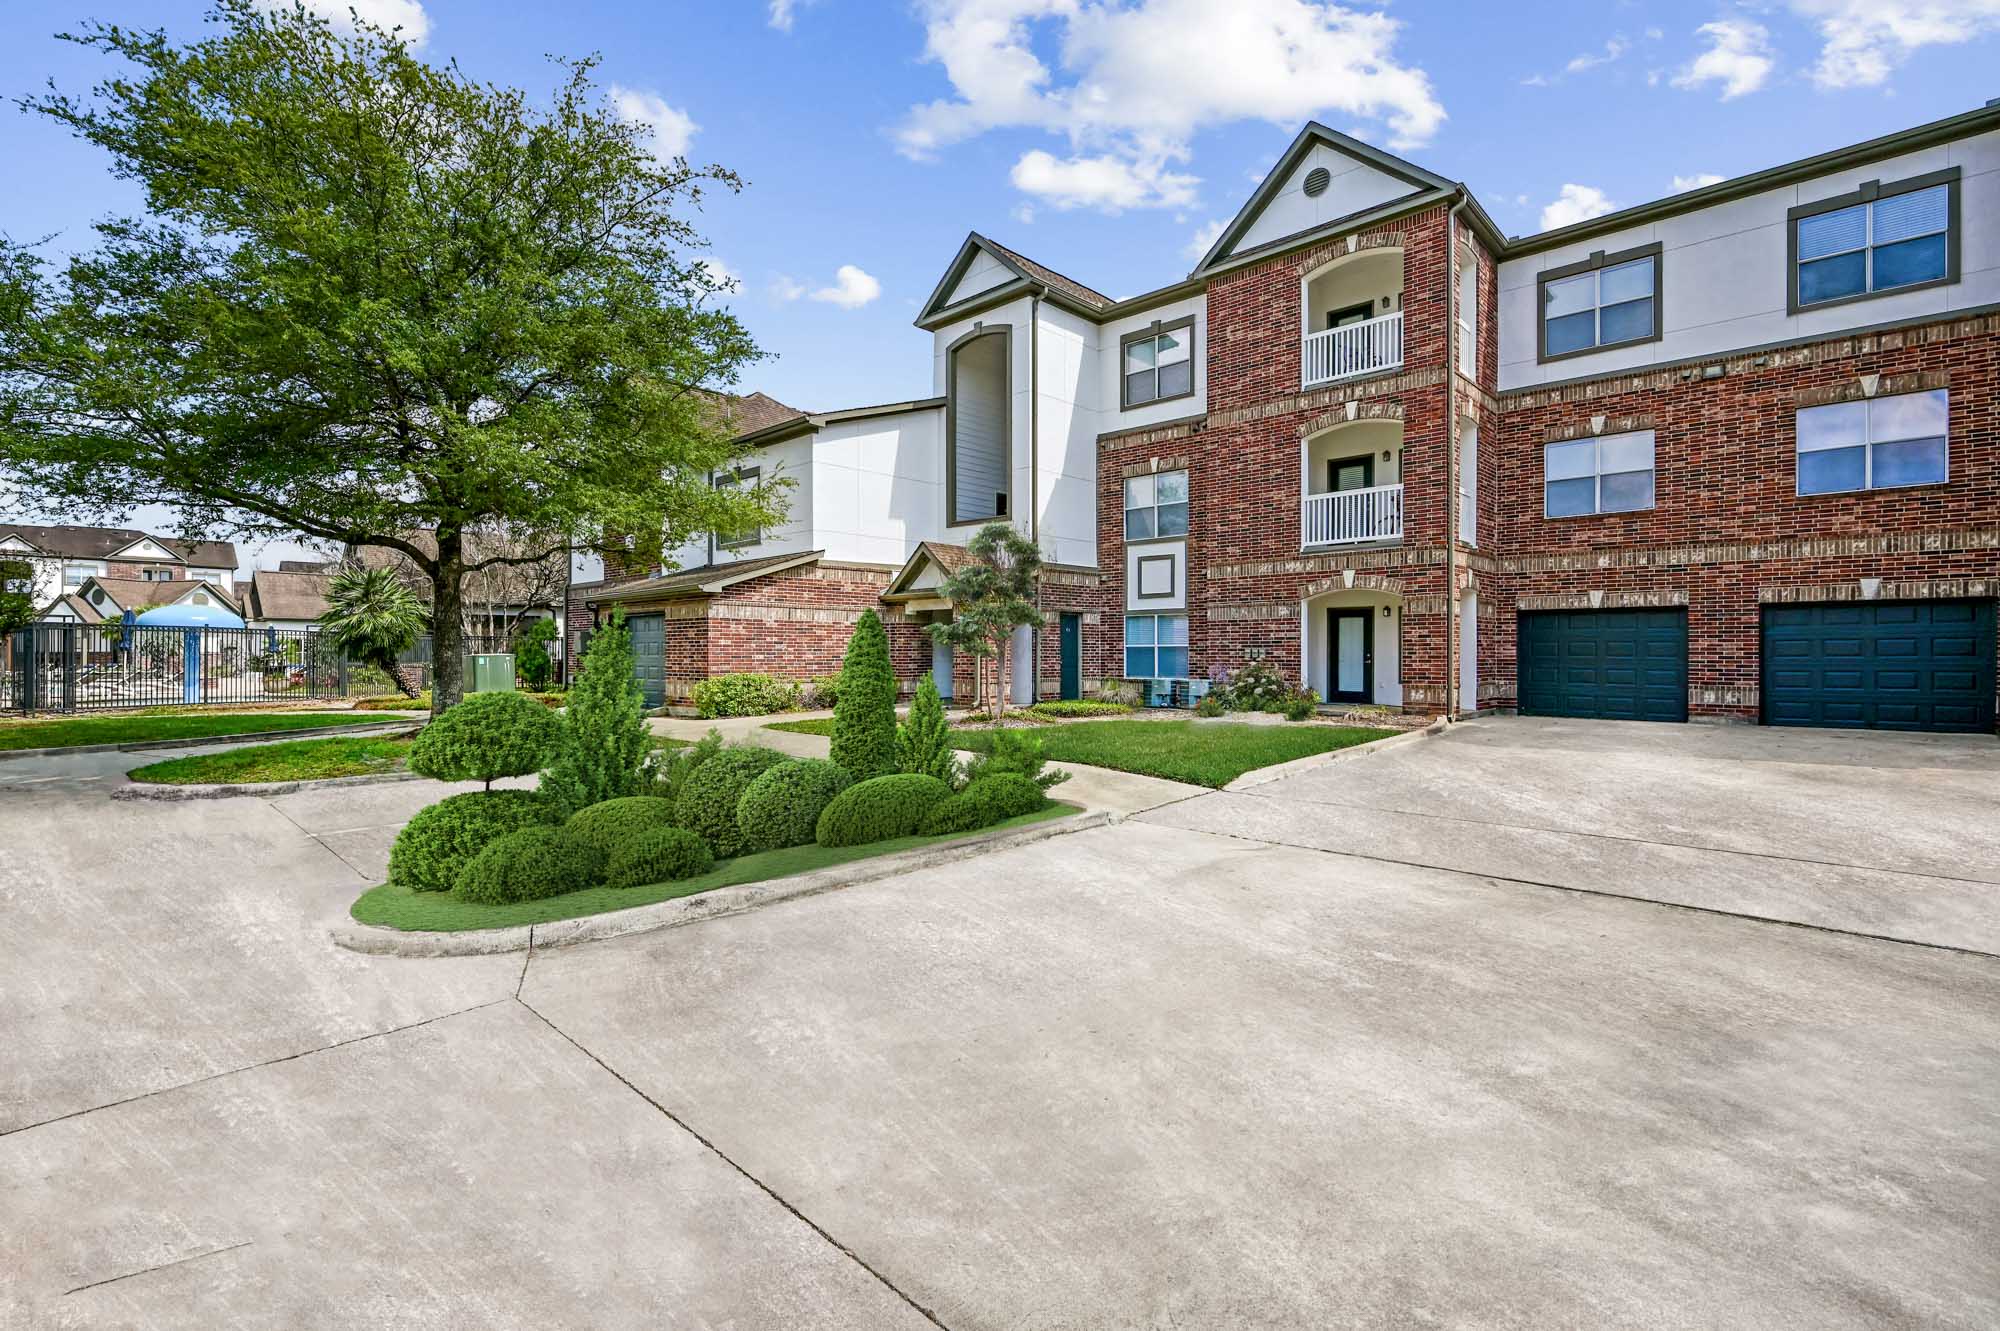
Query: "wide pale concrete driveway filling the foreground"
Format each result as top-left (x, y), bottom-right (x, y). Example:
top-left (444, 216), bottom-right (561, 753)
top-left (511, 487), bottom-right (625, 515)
top-left (0, 721), bottom-right (2000, 1331)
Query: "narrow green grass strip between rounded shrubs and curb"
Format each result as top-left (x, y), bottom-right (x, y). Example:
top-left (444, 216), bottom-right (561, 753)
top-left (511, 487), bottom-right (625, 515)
top-left (352, 803), bottom-right (1082, 933)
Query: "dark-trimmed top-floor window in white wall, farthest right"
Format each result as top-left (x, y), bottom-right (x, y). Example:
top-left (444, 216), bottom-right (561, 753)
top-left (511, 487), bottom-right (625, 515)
top-left (1790, 168), bottom-right (1958, 314)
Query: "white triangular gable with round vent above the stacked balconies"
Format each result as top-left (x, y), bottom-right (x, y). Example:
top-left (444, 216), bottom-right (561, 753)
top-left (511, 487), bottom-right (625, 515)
top-left (1196, 122), bottom-right (1454, 274)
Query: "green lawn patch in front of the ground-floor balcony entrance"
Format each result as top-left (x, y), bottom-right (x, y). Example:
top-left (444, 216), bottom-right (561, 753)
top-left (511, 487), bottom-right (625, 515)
top-left (952, 721), bottom-right (1394, 789)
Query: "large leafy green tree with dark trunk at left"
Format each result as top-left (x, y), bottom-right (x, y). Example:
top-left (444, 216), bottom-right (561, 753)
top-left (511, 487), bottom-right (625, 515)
top-left (0, 0), bottom-right (778, 709)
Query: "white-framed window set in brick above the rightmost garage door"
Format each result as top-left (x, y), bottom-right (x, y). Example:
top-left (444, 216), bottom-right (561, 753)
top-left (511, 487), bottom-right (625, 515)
top-left (1798, 388), bottom-right (1952, 494)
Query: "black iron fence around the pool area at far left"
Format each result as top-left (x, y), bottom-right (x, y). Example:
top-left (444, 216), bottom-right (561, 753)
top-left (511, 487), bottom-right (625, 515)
top-left (0, 624), bottom-right (346, 711)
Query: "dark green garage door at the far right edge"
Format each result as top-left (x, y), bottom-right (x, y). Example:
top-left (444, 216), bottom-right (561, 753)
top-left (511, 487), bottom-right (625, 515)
top-left (1764, 602), bottom-right (1994, 731)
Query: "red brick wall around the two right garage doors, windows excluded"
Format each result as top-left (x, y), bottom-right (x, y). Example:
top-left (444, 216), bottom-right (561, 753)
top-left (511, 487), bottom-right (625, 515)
top-left (1480, 318), bottom-right (2000, 719)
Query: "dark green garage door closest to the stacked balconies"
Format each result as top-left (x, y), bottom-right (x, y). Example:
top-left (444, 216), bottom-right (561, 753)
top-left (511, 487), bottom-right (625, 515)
top-left (1518, 610), bottom-right (1688, 721)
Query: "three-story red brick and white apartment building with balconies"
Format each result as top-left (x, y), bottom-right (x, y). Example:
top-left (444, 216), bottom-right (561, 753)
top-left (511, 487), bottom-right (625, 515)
top-left (584, 106), bottom-right (2000, 731)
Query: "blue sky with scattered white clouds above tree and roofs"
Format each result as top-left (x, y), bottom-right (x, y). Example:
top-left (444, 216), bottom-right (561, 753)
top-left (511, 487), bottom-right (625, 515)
top-left (0, 0), bottom-right (2000, 563)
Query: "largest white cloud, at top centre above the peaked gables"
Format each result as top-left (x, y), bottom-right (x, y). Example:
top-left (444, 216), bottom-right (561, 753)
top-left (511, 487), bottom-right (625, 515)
top-left (896, 0), bottom-right (1444, 210)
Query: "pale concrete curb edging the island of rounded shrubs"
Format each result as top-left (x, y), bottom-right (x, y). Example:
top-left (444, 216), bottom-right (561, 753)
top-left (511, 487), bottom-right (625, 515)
top-left (328, 811), bottom-right (1112, 957)
